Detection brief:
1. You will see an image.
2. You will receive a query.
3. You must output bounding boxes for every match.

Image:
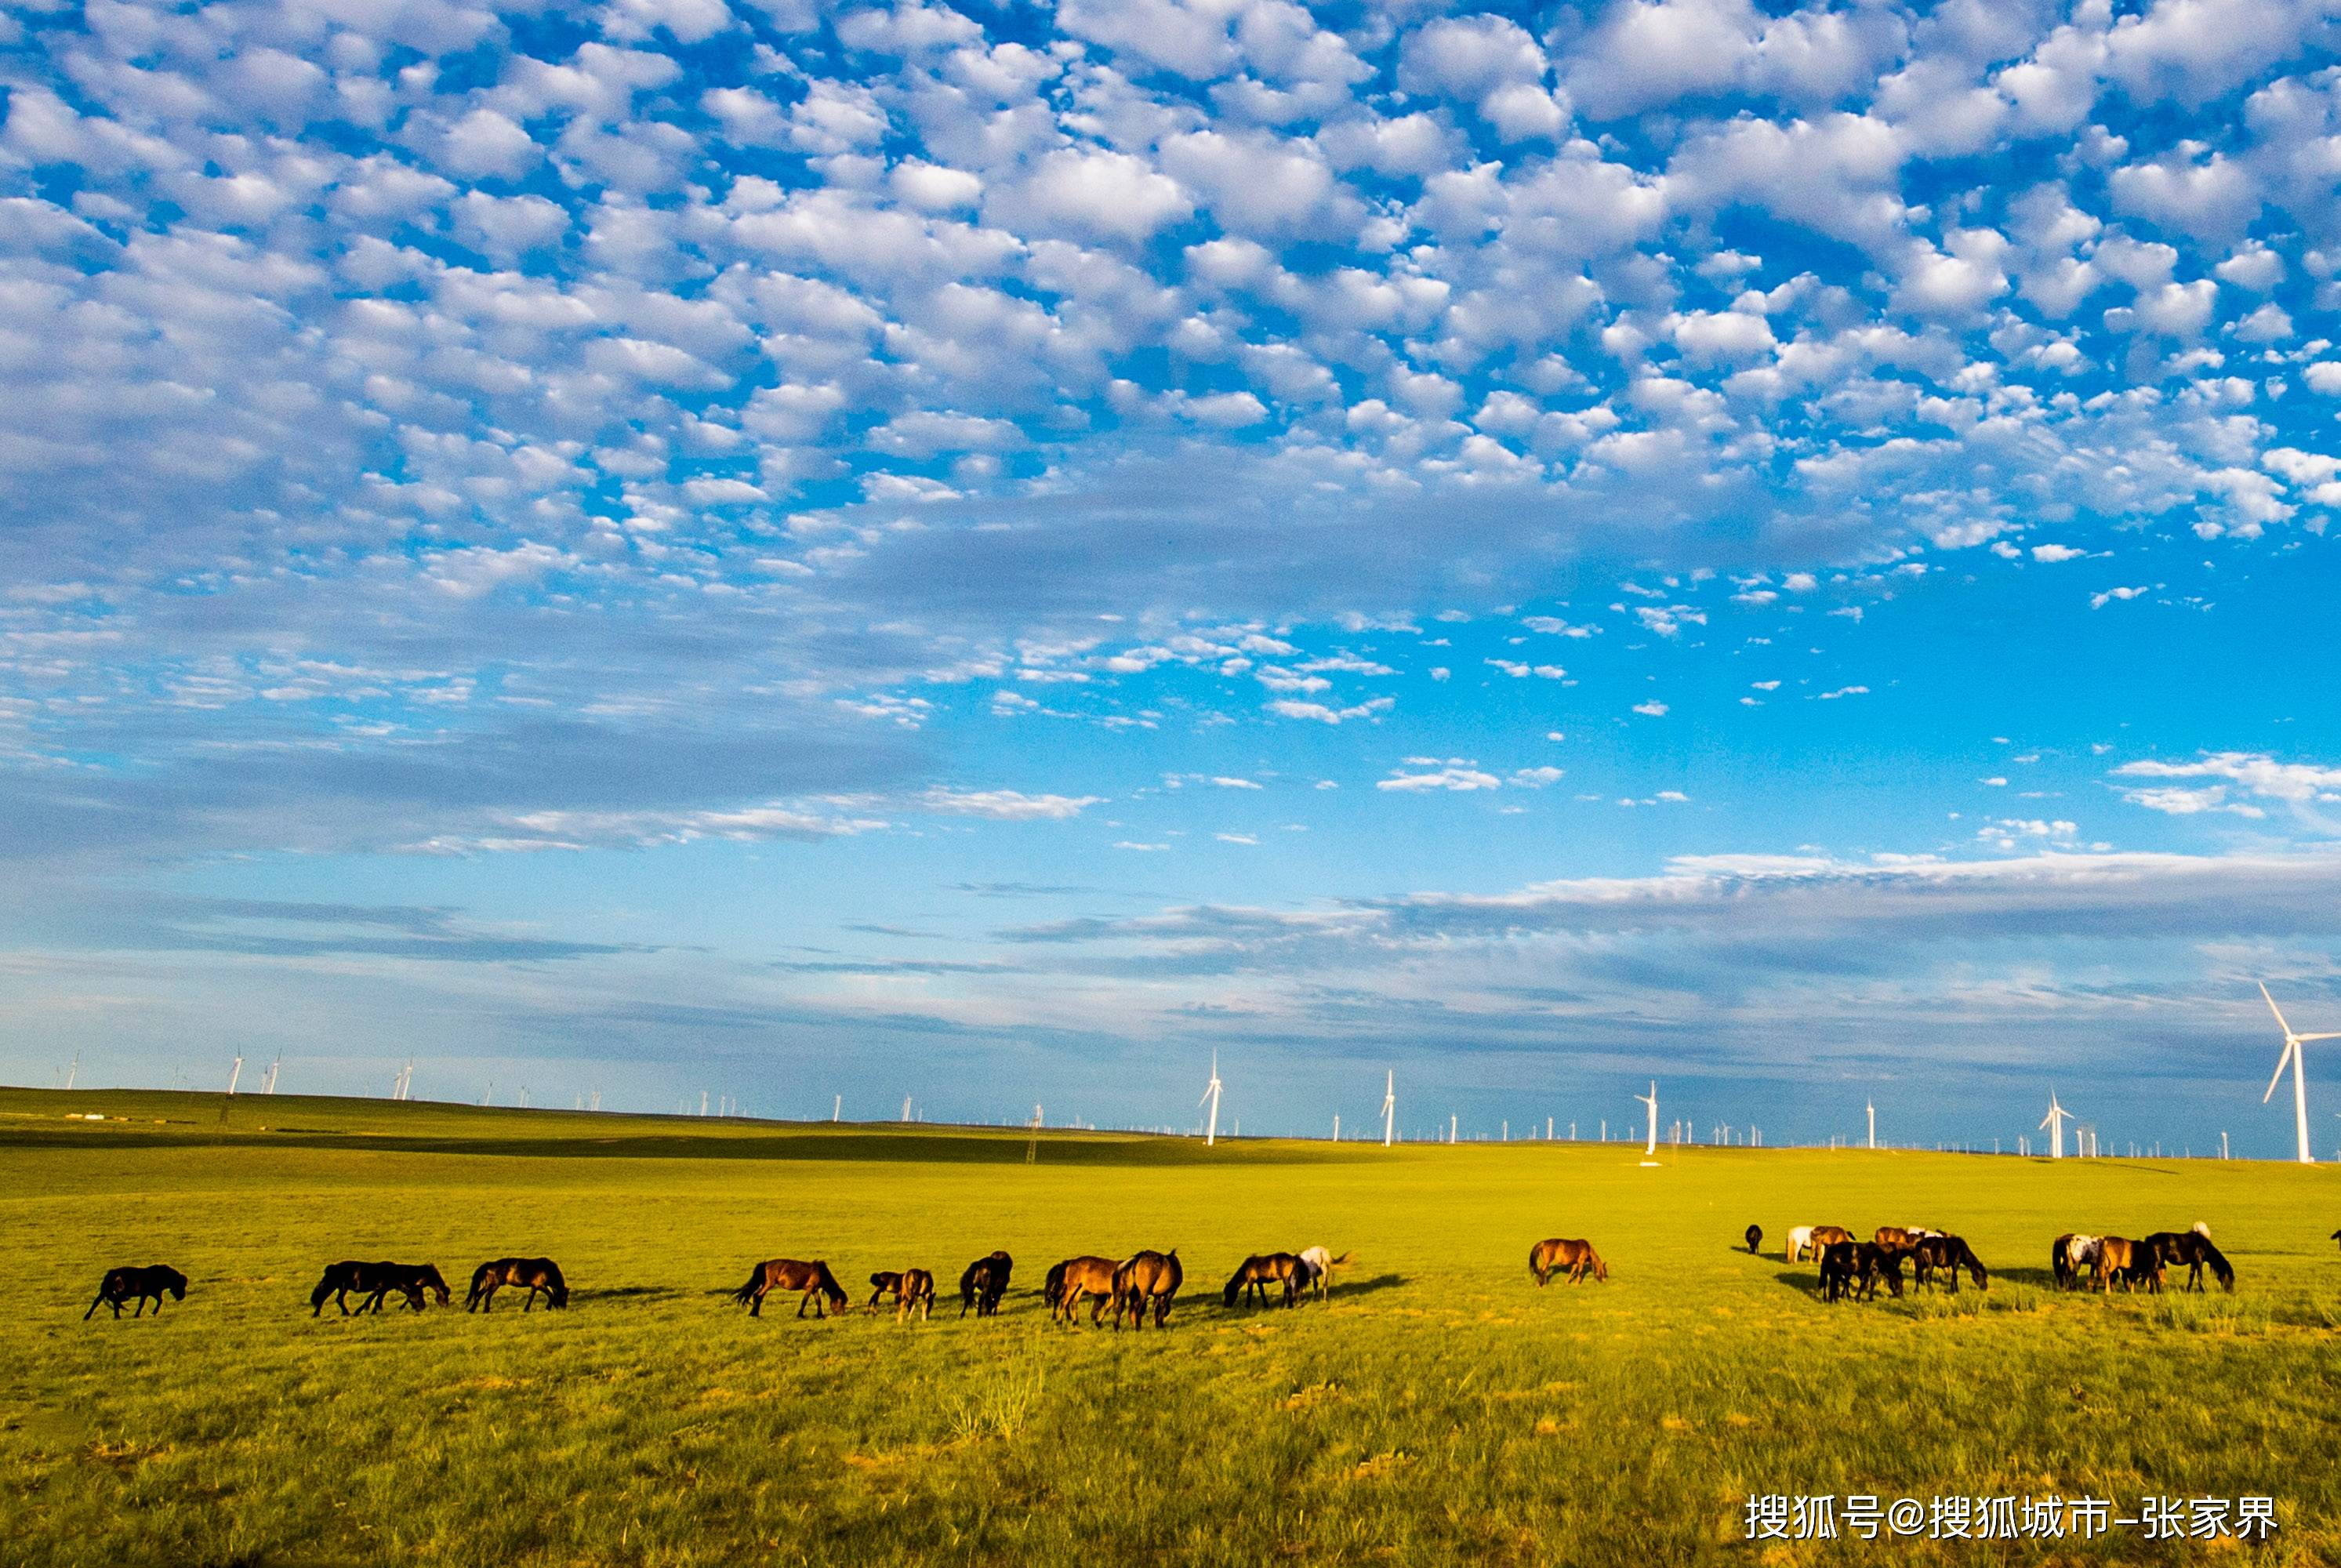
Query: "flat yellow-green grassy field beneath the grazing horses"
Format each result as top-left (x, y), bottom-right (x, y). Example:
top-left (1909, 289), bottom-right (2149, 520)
top-left (0, 1091), bottom-right (2341, 1566)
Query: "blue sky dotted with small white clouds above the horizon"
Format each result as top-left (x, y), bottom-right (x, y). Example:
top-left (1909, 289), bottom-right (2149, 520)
top-left (0, 0), bottom-right (2341, 1152)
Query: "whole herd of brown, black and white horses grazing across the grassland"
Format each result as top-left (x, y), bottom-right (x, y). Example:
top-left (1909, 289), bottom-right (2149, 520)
top-left (82, 1221), bottom-right (2285, 1332)
